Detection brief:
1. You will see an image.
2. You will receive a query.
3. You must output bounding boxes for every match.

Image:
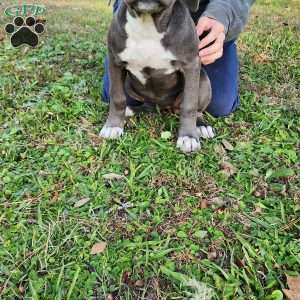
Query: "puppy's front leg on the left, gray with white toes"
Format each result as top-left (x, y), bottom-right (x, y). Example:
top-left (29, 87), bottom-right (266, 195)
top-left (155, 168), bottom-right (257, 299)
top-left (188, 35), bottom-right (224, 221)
top-left (100, 53), bottom-right (126, 139)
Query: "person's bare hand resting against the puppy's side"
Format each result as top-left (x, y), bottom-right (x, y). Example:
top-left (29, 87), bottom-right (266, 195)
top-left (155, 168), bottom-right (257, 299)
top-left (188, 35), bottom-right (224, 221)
top-left (196, 17), bottom-right (225, 65)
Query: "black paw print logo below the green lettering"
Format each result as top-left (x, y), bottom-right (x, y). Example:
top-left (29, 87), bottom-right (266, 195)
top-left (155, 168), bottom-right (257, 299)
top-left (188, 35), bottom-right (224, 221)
top-left (5, 16), bottom-right (45, 47)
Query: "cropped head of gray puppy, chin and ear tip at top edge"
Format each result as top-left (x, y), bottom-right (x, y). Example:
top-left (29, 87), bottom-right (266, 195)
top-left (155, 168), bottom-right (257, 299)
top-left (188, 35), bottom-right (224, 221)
top-left (124, 0), bottom-right (199, 14)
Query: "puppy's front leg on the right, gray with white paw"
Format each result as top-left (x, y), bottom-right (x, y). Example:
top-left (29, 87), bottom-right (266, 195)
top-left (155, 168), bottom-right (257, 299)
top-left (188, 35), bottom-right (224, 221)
top-left (177, 60), bottom-right (201, 153)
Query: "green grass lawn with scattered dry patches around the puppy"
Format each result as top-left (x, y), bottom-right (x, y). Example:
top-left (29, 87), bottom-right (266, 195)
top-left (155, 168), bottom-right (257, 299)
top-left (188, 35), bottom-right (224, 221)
top-left (0, 0), bottom-right (300, 300)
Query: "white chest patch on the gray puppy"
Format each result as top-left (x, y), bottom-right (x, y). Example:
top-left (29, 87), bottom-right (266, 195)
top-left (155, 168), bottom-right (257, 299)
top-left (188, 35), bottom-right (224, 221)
top-left (120, 12), bottom-right (175, 84)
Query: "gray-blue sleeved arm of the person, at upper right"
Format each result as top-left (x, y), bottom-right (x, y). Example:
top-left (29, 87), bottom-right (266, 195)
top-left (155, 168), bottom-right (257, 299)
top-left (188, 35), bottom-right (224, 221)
top-left (202, 0), bottom-right (255, 41)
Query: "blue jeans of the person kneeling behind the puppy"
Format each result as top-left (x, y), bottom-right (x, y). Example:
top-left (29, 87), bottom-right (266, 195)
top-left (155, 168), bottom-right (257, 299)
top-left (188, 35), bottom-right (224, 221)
top-left (102, 0), bottom-right (240, 117)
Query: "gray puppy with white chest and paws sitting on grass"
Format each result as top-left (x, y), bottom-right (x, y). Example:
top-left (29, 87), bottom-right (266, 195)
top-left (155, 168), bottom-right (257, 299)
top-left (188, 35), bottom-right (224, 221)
top-left (100, 0), bottom-right (214, 153)
